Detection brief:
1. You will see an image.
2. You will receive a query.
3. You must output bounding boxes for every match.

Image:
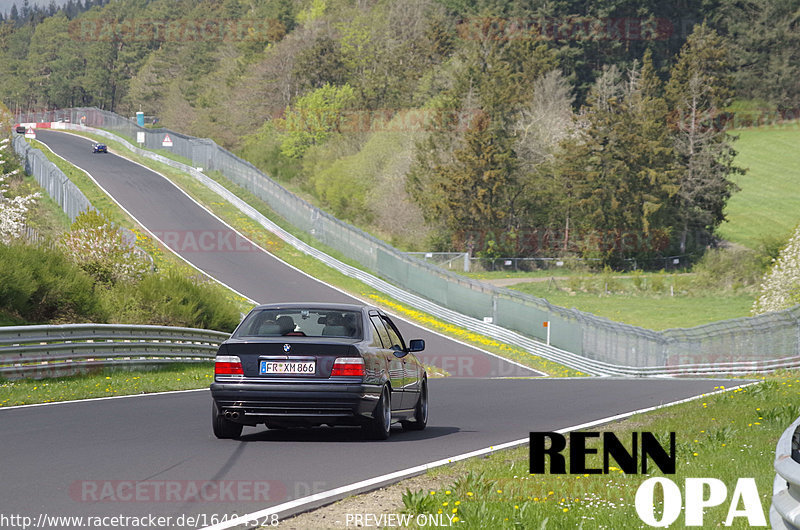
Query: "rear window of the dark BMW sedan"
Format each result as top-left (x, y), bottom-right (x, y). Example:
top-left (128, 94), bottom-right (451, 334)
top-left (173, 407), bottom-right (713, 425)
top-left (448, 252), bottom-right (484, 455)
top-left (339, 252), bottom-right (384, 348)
top-left (233, 309), bottom-right (364, 339)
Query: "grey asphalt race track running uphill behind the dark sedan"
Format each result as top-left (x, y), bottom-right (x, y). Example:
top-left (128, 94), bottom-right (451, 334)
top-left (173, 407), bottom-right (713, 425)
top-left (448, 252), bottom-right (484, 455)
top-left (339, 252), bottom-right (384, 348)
top-left (0, 130), bottom-right (744, 528)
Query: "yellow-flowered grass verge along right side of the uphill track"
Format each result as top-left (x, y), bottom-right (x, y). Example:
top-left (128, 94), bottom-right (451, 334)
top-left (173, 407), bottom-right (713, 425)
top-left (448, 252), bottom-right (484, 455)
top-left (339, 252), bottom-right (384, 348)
top-left (28, 132), bottom-right (586, 377)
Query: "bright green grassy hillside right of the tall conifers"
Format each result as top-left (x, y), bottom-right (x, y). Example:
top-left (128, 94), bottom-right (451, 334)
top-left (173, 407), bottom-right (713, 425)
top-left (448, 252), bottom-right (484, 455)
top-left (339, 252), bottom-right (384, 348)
top-left (719, 122), bottom-right (800, 249)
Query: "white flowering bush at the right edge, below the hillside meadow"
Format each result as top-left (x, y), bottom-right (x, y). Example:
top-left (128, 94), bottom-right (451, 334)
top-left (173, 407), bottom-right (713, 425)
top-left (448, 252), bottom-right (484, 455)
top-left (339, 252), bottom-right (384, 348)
top-left (752, 226), bottom-right (800, 315)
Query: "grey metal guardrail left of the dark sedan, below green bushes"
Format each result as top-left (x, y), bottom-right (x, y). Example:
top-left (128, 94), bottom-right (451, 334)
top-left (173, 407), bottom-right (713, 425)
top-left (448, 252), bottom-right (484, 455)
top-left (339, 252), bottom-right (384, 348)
top-left (0, 324), bottom-right (230, 379)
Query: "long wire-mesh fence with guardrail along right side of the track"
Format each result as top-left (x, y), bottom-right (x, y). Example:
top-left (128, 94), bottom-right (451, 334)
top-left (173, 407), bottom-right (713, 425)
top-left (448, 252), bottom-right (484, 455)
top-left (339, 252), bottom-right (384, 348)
top-left (15, 108), bottom-right (800, 375)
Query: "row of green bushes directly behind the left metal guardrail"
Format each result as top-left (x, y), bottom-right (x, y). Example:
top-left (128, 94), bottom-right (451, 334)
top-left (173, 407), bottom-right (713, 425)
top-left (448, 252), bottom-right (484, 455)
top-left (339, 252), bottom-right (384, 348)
top-left (0, 243), bottom-right (240, 331)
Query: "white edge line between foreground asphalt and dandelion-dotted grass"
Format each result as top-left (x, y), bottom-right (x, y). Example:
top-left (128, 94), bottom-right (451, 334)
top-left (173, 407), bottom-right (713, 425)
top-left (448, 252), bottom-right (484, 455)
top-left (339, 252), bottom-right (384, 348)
top-left (202, 381), bottom-right (761, 530)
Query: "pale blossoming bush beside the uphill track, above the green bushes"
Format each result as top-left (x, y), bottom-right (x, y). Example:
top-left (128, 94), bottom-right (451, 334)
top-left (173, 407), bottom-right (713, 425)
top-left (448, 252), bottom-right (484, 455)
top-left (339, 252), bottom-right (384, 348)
top-left (58, 211), bottom-right (150, 284)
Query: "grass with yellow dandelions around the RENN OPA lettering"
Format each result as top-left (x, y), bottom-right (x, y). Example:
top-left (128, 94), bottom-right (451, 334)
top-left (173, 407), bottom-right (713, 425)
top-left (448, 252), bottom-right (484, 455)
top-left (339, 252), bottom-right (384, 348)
top-left (396, 372), bottom-right (800, 529)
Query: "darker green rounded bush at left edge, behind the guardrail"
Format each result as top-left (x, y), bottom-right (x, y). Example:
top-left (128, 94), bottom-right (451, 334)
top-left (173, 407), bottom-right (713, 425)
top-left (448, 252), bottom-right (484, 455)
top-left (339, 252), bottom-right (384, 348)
top-left (0, 243), bottom-right (106, 323)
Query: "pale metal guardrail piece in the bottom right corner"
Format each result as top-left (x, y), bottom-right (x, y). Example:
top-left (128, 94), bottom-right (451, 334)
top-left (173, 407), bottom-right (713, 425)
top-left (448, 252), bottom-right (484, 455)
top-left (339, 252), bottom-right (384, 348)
top-left (769, 418), bottom-right (800, 530)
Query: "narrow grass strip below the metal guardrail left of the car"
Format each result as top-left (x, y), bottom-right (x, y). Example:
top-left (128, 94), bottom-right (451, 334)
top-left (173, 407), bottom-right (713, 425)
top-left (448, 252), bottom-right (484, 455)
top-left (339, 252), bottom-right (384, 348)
top-left (0, 362), bottom-right (214, 407)
